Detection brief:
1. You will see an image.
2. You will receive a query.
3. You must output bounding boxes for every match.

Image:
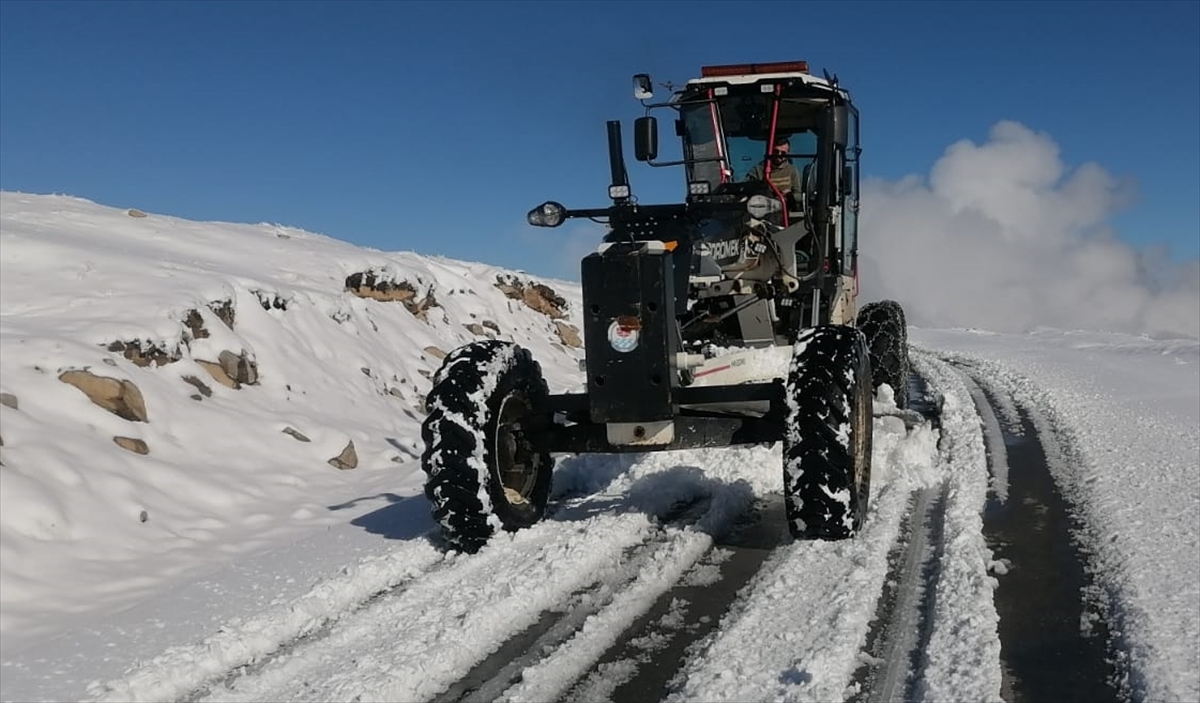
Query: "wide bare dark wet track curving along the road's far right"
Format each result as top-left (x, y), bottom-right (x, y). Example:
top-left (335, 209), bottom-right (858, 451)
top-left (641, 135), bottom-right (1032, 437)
top-left (955, 365), bottom-right (1129, 703)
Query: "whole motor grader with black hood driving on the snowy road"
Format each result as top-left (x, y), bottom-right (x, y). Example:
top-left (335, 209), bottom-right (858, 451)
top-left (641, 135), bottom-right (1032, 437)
top-left (422, 61), bottom-right (908, 552)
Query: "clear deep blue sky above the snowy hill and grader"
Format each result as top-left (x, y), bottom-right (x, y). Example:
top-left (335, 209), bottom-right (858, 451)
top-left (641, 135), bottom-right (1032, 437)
top-left (0, 0), bottom-right (1200, 278)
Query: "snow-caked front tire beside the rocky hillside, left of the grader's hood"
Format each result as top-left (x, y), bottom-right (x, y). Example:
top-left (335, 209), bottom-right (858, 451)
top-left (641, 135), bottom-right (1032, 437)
top-left (421, 340), bottom-right (553, 553)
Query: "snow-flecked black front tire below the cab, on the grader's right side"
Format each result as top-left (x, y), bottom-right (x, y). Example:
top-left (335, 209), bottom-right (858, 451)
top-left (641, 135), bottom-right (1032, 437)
top-left (784, 325), bottom-right (872, 540)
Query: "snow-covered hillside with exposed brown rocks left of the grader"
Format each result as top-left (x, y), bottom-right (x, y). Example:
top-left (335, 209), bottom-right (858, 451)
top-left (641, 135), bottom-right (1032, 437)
top-left (0, 193), bottom-right (590, 650)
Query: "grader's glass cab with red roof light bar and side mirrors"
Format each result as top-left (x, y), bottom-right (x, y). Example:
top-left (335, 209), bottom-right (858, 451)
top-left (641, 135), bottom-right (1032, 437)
top-left (634, 61), bottom-right (862, 283)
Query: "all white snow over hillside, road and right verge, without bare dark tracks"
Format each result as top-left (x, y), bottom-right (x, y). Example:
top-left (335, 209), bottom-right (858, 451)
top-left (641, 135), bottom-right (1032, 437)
top-left (0, 193), bottom-right (1200, 701)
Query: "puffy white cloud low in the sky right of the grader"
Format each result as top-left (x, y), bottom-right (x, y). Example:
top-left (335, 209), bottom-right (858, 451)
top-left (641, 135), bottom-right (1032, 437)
top-left (860, 121), bottom-right (1200, 337)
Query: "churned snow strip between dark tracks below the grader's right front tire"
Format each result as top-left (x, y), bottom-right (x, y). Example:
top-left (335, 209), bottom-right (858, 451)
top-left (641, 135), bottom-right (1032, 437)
top-left (588, 369), bottom-right (941, 701)
